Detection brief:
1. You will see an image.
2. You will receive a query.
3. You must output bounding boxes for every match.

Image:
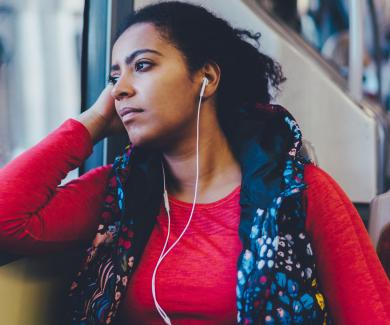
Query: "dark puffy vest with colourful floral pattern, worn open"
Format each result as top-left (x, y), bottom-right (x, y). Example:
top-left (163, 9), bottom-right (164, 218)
top-left (69, 104), bottom-right (332, 325)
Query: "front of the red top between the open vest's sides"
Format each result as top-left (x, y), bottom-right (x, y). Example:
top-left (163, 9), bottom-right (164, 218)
top-left (120, 188), bottom-right (242, 325)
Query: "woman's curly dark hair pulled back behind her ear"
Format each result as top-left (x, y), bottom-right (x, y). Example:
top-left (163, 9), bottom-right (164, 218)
top-left (118, 1), bottom-right (285, 136)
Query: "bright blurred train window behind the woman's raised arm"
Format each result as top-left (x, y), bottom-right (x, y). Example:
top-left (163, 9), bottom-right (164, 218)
top-left (0, 0), bottom-right (84, 175)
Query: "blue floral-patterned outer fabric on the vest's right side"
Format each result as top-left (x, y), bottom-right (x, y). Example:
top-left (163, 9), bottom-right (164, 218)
top-left (236, 105), bottom-right (332, 325)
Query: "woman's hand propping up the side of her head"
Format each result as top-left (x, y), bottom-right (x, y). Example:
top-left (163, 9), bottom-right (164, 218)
top-left (77, 85), bottom-right (125, 143)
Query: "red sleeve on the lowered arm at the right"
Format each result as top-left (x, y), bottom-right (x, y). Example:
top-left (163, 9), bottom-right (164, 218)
top-left (305, 165), bottom-right (390, 325)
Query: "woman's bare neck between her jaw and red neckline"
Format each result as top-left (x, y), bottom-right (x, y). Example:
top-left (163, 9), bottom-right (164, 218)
top-left (164, 106), bottom-right (241, 203)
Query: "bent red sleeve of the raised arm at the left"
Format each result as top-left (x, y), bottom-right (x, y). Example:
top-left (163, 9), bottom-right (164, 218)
top-left (0, 119), bottom-right (111, 254)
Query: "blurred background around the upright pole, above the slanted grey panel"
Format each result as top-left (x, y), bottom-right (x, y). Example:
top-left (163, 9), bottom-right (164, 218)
top-left (257, 0), bottom-right (390, 106)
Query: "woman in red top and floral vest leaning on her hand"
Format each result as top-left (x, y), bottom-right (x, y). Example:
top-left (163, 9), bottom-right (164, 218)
top-left (0, 2), bottom-right (390, 324)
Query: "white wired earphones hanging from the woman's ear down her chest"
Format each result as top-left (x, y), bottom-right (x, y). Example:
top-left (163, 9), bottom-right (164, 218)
top-left (152, 77), bottom-right (209, 325)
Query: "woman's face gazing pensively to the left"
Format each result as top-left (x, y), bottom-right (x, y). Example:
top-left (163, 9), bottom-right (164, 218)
top-left (111, 23), bottom-right (202, 149)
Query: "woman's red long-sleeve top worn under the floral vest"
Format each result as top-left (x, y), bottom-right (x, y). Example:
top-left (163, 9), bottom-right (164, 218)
top-left (0, 119), bottom-right (390, 324)
